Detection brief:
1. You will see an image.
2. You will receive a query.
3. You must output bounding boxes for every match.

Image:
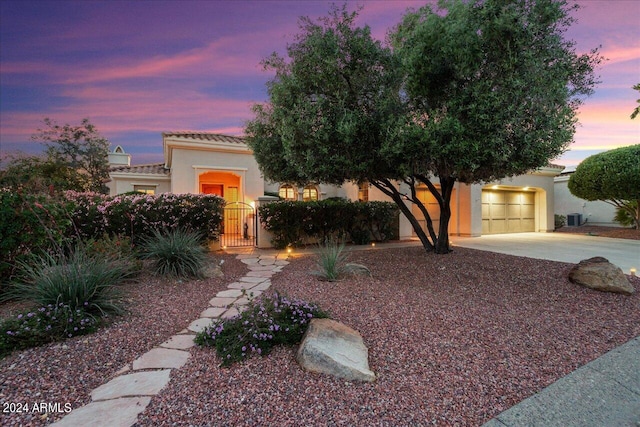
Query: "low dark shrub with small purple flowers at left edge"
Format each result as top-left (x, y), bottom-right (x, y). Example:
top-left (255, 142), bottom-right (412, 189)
top-left (0, 303), bottom-right (101, 358)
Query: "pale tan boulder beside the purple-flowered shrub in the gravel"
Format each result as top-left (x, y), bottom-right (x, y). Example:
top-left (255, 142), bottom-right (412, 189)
top-left (297, 319), bottom-right (376, 381)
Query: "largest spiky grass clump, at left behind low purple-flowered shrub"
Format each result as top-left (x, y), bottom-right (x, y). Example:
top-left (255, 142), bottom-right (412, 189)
top-left (6, 246), bottom-right (134, 316)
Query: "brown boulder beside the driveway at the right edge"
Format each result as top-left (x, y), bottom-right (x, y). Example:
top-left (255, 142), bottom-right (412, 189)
top-left (569, 257), bottom-right (635, 295)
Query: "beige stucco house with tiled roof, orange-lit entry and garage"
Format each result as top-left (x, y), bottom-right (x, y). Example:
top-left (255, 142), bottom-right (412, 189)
top-left (108, 132), bottom-right (564, 249)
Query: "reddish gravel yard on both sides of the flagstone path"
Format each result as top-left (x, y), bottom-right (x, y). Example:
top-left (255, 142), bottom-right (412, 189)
top-left (0, 247), bottom-right (640, 426)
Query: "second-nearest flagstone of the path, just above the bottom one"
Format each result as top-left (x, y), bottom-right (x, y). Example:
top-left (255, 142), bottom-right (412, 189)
top-left (91, 369), bottom-right (171, 401)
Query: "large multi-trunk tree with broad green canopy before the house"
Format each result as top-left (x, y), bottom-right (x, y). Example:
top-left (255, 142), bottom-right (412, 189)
top-left (247, 0), bottom-right (599, 253)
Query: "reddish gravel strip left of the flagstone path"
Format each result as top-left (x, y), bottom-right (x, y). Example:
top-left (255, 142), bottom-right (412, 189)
top-left (0, 255), bottom-right (247, 427)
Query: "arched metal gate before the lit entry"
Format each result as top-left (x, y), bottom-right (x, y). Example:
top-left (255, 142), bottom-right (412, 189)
top-left (220, 202), bottom-right (258, 247)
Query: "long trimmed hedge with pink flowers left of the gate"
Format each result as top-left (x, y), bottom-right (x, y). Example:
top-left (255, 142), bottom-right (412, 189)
top-left (65, 191), bottom-right (225, 243)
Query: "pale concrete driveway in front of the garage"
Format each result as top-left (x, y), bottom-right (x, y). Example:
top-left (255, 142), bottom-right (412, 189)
top-left (451, 233), bottom-right (640, 274)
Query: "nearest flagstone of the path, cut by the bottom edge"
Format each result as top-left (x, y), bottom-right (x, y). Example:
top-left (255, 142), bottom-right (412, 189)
top-left (51, 396), bottom-right (151, 427)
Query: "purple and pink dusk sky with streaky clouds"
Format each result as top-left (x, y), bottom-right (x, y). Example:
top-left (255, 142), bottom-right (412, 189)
top-left (0, 0), bottom-right (640, 166)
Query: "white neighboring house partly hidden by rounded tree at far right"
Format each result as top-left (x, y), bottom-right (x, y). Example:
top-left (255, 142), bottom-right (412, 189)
top-left (553, 171), bottom-right (620, 227)
